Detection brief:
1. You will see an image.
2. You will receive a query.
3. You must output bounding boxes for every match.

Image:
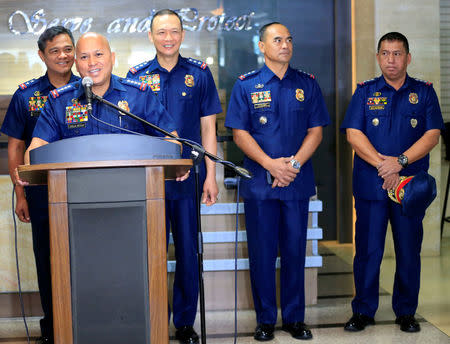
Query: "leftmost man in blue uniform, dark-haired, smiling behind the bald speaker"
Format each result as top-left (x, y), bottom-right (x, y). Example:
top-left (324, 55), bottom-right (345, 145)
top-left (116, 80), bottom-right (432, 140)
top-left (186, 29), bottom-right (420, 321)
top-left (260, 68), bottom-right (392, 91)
top-left (1, 26), bottom-right (79, 343)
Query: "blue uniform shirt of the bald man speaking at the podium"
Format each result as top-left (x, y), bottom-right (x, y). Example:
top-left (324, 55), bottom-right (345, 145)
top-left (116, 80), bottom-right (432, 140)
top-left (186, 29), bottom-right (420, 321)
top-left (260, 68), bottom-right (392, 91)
top-left (33, 75), bottom-right (175, 142)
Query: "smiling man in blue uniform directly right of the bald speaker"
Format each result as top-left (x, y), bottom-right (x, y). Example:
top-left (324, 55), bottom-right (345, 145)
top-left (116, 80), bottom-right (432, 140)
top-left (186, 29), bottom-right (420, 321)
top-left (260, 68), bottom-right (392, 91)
top-left (127, 9), bottom-right (222, 344)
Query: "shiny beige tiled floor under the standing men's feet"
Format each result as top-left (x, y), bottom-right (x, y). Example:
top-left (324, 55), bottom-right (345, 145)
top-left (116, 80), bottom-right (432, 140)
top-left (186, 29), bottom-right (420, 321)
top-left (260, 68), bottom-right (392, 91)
top-left (0, 238), bottom-right (450, 344)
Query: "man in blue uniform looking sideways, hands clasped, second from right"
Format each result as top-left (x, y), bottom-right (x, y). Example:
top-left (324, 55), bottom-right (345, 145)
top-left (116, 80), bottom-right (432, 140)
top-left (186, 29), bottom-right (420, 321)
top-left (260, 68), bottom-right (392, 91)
top-left (225, 22), bottom-right (330, 341)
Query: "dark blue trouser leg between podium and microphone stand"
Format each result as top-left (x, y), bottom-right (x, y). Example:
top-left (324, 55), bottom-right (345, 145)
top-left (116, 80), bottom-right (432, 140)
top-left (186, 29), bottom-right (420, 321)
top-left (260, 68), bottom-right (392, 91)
top-left (166, 198), bottom-right (199, 328)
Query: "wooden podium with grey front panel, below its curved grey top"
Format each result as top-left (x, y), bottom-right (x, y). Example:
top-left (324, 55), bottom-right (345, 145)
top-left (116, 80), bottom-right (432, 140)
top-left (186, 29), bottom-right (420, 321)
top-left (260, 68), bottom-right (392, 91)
top-left (19, 135), bottom-right (192, 344)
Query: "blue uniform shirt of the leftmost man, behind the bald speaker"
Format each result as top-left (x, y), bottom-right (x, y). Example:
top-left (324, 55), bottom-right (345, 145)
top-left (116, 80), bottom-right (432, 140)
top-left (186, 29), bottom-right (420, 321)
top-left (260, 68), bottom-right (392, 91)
top-left (1, 73), bottom-right (80, 147)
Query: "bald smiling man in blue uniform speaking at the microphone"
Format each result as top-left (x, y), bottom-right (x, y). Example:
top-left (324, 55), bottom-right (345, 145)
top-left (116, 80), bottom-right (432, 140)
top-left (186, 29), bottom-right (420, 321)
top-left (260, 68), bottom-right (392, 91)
top-left (25, 32), bottom-right (181, 162)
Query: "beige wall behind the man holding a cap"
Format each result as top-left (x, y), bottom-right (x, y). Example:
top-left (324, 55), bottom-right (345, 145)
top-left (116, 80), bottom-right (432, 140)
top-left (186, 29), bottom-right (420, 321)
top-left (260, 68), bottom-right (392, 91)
top-left (354, 0), bottom-right (442, 255)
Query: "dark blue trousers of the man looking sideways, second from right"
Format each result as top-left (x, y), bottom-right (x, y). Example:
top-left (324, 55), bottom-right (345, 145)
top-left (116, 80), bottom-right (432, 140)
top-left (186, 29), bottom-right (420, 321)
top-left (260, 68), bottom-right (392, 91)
top-left (244, 200), bottom-right (309, 324)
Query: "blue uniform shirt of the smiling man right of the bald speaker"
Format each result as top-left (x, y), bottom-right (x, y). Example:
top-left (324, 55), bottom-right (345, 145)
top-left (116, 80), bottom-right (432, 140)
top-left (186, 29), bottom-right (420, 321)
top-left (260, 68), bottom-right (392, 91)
top-left (127, 56), bottom-right (222, 199)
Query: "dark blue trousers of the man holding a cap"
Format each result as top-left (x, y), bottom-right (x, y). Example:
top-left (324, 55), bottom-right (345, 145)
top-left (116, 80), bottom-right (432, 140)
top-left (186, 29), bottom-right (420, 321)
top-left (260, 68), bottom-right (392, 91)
top-left (352, 199), bottom-right (423, 317)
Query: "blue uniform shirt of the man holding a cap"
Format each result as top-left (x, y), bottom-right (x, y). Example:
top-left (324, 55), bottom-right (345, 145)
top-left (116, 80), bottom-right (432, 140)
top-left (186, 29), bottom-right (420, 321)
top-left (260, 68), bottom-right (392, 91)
top-left (341, 75), bottom-right (444, 200)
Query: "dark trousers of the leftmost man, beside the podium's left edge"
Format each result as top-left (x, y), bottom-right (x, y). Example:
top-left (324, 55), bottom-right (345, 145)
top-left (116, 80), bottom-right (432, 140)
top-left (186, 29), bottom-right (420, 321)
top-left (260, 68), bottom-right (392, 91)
top-left (25, 186), bottom-right (53, 338)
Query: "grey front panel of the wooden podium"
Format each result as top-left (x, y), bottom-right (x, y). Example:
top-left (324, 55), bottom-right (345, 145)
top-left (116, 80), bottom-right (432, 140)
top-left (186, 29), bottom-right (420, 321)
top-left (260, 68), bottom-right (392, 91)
top-left (67, 168), bottom-right (151, 344)
